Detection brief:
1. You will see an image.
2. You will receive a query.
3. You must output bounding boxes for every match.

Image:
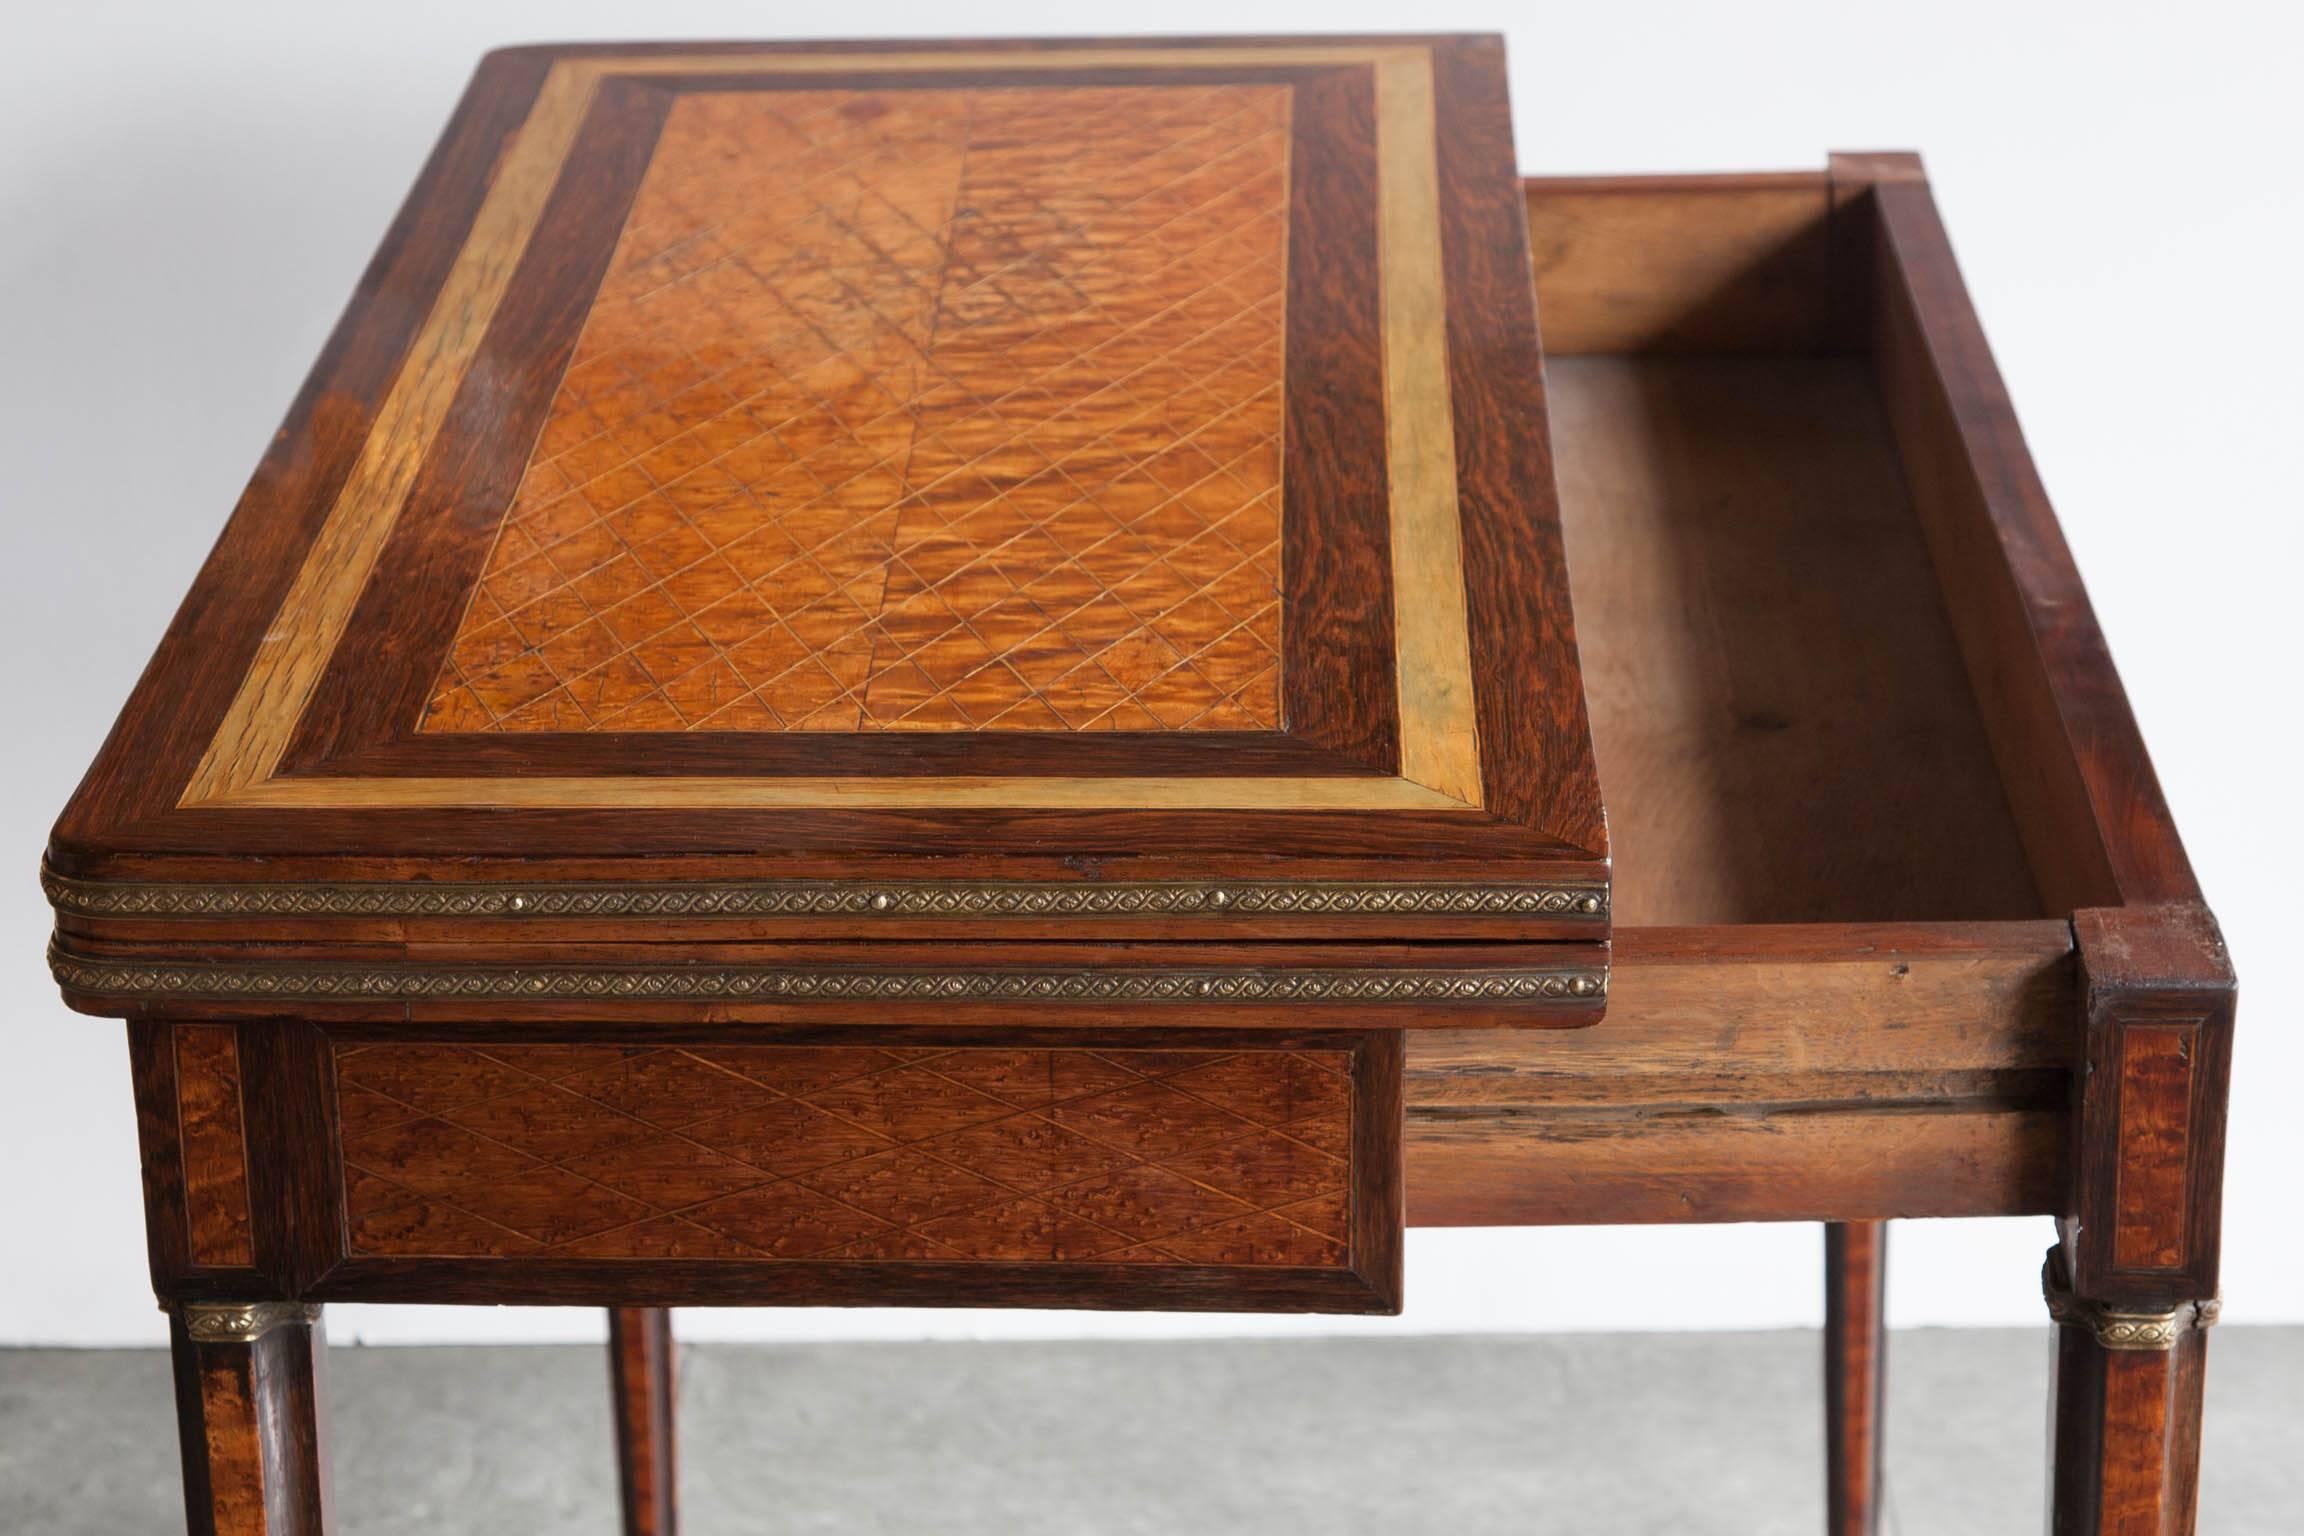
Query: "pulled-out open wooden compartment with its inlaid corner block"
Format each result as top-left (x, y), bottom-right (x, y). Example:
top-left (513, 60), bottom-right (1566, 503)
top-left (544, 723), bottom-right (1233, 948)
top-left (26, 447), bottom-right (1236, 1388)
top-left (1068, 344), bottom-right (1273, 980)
top-left (1408, 154), bottom-right (2230, 1299)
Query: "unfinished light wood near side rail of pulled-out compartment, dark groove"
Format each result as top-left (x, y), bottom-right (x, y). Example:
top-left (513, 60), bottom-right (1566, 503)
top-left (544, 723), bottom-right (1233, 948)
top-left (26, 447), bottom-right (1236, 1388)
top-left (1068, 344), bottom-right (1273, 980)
top-left (1408, 921), bottom-right (2078, 1225)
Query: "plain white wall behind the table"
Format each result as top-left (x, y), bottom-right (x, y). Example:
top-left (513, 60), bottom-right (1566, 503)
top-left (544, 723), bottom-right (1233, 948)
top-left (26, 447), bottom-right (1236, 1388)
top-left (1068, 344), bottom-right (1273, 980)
top-left (0, 0), bottom-right (2304, 1343)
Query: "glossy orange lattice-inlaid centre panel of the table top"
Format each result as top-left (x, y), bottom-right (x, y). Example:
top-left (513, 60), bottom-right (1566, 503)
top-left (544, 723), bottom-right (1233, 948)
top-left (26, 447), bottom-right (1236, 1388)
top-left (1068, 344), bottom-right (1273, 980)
top-left (422, 85), bottom-right (1288, 732)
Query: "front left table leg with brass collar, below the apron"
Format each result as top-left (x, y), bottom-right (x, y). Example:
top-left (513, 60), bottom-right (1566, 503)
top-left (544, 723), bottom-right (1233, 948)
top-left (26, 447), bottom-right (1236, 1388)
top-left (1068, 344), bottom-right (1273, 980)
top-left (170, 1301), bottom-right (327, 1536)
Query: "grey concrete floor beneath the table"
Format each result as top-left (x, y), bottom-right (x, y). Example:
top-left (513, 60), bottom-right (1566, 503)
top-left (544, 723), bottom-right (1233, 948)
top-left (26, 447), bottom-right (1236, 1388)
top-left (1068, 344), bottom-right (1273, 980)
top-left (0, 1329), bottom-right (2304, 1536)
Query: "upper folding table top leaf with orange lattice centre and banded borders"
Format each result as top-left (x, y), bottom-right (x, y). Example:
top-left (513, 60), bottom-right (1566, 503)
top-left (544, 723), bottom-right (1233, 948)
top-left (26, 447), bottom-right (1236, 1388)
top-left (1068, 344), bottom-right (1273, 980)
top-left (51, 39), bottom-right (1606, 935)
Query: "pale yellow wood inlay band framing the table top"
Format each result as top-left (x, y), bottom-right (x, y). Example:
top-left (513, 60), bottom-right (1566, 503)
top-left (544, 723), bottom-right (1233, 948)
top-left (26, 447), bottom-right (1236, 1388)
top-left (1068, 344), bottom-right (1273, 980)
top-left (177, 46), bottom-right (1481, 811)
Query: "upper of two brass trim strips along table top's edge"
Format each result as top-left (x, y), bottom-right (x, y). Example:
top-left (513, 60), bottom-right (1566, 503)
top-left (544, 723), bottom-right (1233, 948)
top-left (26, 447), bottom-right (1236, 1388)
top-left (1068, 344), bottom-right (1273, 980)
top-left (39, 868), bottom-right (1608, 923)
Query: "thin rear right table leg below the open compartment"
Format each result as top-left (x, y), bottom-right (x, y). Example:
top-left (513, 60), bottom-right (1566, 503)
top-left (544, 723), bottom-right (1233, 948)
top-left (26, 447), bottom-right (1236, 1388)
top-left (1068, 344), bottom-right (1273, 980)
top-left (1825, 1221), bottom-right (1887, 1536)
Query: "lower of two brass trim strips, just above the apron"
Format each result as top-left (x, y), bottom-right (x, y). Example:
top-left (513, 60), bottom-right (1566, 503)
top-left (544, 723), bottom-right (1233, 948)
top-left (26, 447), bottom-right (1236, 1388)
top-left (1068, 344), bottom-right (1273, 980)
top-left (48, 944), bottom-right (1608, 1006)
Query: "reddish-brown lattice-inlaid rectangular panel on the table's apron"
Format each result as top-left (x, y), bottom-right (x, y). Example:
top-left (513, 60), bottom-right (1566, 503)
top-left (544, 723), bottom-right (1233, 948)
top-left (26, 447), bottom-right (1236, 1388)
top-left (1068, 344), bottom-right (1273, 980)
top-left (336, 1043), bottom-right (1352, 1269)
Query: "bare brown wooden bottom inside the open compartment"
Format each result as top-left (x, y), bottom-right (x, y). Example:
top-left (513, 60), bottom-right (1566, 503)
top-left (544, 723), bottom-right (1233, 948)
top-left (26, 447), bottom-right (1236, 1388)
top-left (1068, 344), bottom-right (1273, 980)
top-left (1548, 355), bottom-right (2039, 930)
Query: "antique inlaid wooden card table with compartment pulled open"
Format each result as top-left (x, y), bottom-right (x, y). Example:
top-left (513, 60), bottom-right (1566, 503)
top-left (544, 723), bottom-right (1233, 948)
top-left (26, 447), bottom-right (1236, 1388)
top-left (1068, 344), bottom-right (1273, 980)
top-left (46, 37), bottom-right (2233, 1534)
